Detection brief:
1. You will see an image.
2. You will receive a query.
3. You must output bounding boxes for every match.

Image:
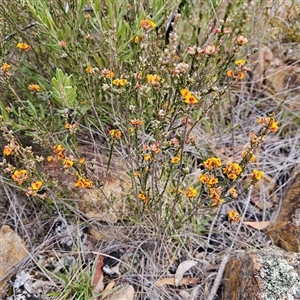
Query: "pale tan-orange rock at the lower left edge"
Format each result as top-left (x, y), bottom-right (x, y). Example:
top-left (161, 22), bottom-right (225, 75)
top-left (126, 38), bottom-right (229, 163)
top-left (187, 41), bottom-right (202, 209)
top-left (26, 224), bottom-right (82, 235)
top-left (0, 225), bottom-right (28, 299)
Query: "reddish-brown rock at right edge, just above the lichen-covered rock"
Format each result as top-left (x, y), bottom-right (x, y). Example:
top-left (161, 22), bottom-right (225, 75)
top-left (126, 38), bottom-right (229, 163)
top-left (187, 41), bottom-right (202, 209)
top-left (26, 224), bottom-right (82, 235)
top-left (267, 172), bottom-right (300, 252)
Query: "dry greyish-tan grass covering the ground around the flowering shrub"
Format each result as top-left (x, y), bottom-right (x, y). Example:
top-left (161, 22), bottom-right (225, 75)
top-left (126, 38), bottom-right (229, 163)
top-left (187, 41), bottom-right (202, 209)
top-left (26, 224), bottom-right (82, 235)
top-left (0, 0), bottom-right (300, 300)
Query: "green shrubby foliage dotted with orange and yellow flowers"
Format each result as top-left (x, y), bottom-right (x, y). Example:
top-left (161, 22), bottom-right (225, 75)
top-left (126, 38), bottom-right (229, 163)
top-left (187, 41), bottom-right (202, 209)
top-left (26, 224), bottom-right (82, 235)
top-left (0, 0), bottom-right (277, 241)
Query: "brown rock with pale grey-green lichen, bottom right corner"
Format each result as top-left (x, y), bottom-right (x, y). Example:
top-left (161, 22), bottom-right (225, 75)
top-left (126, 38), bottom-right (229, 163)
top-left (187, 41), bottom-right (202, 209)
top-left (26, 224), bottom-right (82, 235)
top-left (222, 246), bottom-right (300, 300)
